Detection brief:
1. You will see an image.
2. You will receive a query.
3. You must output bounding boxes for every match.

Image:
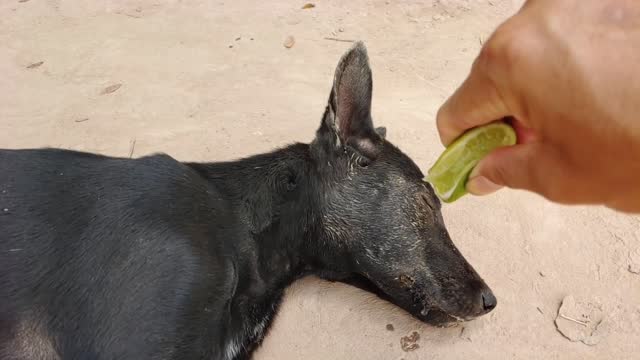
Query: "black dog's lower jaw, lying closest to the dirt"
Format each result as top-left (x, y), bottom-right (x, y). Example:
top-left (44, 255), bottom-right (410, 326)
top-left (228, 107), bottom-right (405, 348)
top-left (341, 274), bottom-right (469, 327)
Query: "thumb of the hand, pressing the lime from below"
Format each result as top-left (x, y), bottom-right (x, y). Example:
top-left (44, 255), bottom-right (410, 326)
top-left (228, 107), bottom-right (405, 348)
top-left (466, 142), bottom-right (564, 197)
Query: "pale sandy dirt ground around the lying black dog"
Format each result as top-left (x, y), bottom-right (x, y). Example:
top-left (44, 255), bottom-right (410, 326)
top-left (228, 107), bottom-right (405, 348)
top-left (0, 0), bottom-right (640, 360)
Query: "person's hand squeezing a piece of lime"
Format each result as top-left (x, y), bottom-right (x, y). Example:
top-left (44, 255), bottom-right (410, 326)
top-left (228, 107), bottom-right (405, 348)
top-left (437, 0), bottom-right (640, 212)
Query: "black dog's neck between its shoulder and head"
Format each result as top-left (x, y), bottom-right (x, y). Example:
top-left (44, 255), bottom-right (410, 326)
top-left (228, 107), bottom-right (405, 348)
top-left (187, 144), bottom-right (321, 286)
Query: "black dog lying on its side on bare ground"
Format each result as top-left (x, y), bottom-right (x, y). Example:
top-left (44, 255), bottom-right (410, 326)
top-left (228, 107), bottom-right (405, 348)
top-left (0, 43), bottom-right (496, 360)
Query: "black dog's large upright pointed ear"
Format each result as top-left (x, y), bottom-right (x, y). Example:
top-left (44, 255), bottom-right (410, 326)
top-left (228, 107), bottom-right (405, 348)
top-left (314, 42), bottom-right (383, 160)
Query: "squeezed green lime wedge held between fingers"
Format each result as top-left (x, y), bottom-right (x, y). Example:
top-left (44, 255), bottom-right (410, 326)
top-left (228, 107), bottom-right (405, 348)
top-left (425, 122), bottom-right (516, 203)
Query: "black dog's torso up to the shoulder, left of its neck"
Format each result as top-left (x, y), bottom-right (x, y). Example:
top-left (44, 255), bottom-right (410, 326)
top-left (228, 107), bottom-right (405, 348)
top-left (0, 150), bottom-right (234, 359)
